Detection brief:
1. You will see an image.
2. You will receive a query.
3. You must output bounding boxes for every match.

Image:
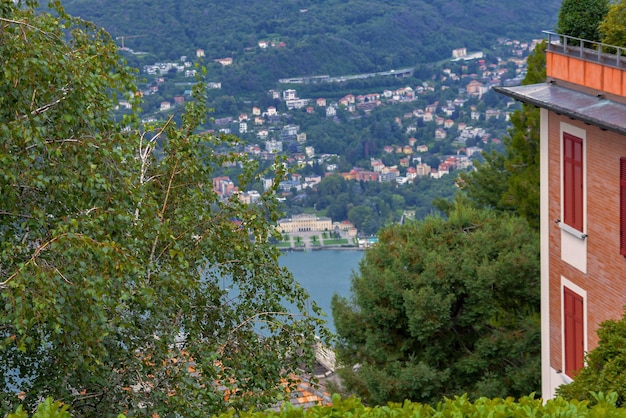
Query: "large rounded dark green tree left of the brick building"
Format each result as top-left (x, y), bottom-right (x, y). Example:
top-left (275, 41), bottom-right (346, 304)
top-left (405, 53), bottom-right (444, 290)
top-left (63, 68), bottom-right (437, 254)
top-left (332, 201), bottom-right (540, 405)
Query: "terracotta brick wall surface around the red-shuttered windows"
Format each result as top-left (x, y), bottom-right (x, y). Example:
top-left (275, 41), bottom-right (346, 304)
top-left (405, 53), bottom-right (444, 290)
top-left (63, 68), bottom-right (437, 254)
top-left (549, 112), bottom-right (626, 370)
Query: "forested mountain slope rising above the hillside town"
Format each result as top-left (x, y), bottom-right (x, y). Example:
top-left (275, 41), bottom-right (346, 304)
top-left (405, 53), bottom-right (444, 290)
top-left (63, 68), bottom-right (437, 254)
top-left (64, 0), bottom-right (561, 90)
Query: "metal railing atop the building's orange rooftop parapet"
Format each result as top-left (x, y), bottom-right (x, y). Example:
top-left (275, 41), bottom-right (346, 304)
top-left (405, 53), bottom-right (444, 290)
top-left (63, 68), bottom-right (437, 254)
top-left (543, 31), bottom-right (626, 69)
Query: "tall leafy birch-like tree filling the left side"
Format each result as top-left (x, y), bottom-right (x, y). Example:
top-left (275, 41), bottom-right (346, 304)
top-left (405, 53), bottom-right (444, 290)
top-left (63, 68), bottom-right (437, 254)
top-left (0, 0), bottom-right (323, 416)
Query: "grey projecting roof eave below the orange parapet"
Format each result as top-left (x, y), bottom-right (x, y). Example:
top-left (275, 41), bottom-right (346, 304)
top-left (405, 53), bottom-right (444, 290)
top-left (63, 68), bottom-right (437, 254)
top-left (494, 82), bottom-right (626, 135)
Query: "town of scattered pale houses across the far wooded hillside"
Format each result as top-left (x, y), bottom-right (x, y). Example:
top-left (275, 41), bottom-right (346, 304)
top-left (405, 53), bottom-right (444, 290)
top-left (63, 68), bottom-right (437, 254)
top-left (120, 38), bottom-right (541, 238)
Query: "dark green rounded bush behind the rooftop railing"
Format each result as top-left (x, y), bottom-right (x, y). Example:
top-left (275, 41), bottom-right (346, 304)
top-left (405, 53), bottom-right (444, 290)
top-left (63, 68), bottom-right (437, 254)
top-left (556, 0), bottom-right (609, 41)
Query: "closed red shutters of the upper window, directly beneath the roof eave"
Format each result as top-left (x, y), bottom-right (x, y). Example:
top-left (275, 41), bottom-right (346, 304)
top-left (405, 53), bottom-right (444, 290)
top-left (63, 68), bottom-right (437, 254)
top-left (563, 132), bottom-right (583, 232)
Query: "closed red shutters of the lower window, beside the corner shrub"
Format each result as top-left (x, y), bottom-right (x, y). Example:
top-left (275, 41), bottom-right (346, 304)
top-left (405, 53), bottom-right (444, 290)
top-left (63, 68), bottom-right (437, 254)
top-left (563, 287), bottom-right (585, 378)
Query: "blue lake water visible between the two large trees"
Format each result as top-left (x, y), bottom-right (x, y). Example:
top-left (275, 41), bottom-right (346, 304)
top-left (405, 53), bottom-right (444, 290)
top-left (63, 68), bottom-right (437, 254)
top-left (279, 250), bottom-right (364, 332)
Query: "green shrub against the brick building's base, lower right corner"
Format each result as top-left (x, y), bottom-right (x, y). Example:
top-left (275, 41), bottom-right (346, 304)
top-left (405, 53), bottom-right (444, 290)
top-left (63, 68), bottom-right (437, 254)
top-left (557, 317), bottom-right (626, 406)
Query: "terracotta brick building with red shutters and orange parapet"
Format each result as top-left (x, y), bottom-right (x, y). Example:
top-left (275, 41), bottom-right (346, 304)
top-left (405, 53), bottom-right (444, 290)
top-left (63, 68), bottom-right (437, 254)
top-left (496, 32), bottom-right (626, 399)
